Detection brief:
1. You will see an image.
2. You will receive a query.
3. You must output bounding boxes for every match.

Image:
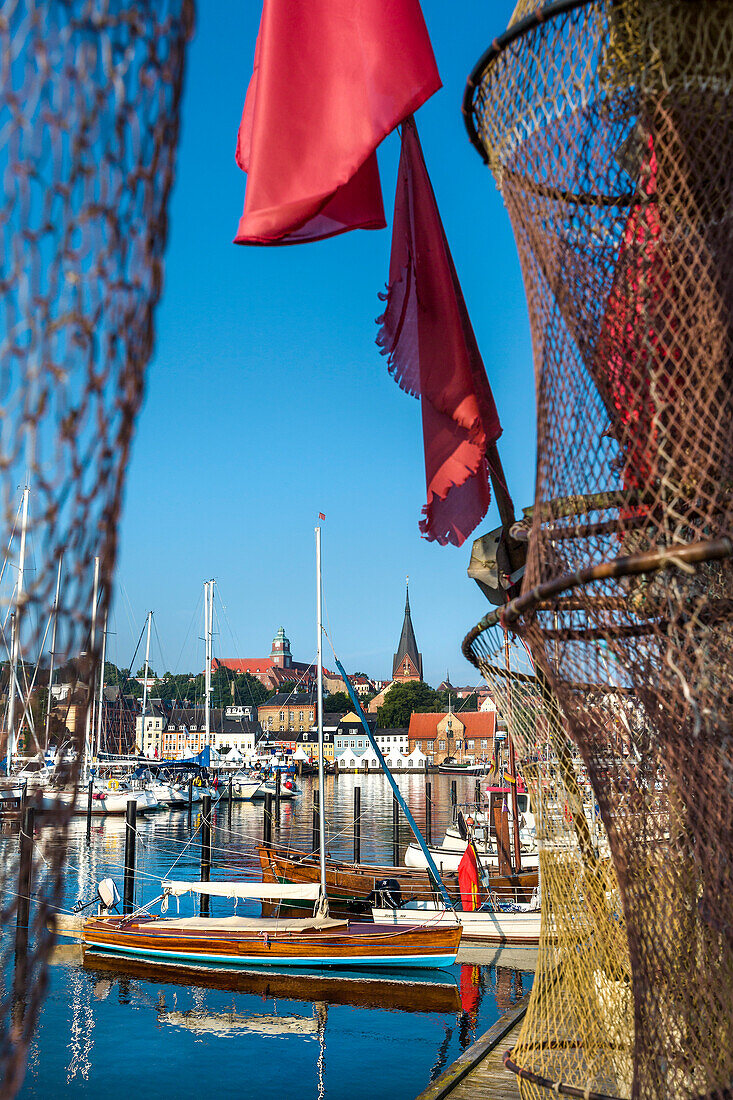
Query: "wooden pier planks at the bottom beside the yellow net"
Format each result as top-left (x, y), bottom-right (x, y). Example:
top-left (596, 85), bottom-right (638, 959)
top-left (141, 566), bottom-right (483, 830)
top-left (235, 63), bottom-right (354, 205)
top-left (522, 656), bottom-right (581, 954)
top-left (416, 993), bottom-right (529, 1100)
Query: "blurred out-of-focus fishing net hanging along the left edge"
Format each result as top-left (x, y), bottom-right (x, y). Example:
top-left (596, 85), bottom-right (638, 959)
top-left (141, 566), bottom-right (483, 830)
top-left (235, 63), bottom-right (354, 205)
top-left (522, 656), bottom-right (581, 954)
top-left (0, 0), bottom-right (193, 1097)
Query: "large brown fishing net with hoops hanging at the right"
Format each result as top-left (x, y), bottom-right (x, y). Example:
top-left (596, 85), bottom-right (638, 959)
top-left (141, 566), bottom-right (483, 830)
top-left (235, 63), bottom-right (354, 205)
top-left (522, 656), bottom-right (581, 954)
top-left (466, 0), bottom-right (733, 1097)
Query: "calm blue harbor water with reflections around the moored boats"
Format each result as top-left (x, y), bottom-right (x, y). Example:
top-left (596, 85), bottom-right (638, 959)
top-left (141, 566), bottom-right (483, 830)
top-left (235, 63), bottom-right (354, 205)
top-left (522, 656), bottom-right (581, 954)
top-left (8, 774), bottom-right (534, 1100)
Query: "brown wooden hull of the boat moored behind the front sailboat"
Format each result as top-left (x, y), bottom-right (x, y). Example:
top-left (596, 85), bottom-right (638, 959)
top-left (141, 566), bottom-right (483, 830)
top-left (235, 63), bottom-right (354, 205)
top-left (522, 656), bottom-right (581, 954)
top-left (258, 845), bottom-right (538, 913)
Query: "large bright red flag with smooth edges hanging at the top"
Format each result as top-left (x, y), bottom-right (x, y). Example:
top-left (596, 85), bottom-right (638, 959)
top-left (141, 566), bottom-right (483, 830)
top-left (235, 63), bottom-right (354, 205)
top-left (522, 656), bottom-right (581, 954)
top-left (234, 0), bottom-right (440, 244)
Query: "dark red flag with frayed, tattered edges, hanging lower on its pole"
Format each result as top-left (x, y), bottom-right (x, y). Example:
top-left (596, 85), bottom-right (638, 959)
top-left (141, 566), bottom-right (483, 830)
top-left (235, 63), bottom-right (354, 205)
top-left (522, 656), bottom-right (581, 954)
top-left (376, 119), bottom-right (502, 546)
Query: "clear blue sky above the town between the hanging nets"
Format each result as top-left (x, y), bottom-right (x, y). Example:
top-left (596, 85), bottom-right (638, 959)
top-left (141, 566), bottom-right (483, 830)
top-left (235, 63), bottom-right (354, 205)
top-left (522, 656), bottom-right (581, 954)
top-left (109, 0), bottom-right (535, 683)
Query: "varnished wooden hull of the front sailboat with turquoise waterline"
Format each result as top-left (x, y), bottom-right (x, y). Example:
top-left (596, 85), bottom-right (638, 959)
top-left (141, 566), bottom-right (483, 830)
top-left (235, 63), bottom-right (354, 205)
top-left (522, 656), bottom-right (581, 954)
top-left (83, 916), bottom-right (461, 969)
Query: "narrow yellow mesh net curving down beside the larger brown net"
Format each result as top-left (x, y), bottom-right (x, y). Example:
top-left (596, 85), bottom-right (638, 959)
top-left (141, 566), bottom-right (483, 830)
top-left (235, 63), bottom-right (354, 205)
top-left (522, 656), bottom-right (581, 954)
top-left (463, 612), bottom-right (634, 1097)
